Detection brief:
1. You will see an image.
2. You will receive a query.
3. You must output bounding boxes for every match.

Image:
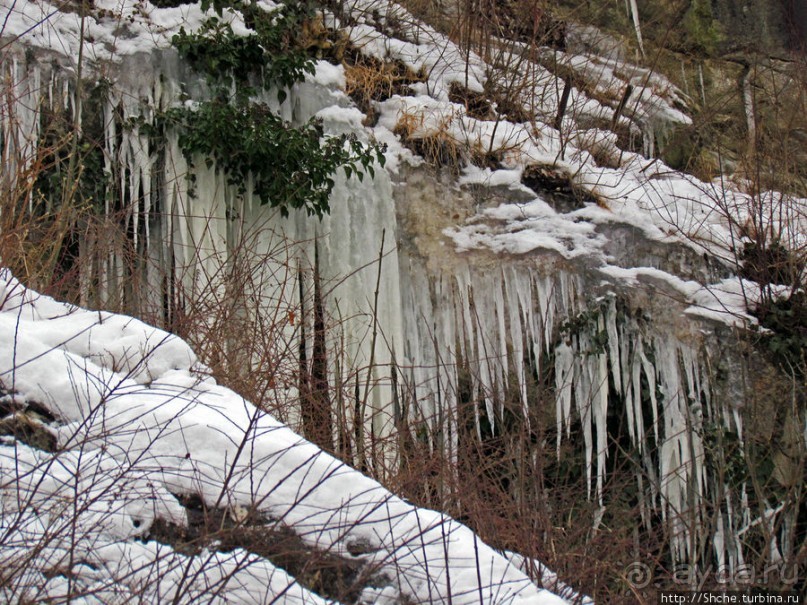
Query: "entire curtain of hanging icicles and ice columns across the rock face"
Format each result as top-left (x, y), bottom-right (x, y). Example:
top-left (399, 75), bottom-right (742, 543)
top-left (0, 48), bottom-right (756, 566)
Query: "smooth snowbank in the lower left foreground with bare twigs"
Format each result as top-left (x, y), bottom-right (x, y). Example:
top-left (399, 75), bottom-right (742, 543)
top-left (0, 269), bottom-right (568, 605)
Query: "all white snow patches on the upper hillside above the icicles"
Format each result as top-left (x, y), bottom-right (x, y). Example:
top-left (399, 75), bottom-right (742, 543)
top-left (3, 0), bottom-right (796, 306)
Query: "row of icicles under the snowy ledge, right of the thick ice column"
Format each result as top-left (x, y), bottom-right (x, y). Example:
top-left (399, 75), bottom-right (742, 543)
top-left (404, 261), bottom-right (756, 569)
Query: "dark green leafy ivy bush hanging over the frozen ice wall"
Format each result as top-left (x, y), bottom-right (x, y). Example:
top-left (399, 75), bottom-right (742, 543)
top-left (166, 0), bottom-right (384, 217)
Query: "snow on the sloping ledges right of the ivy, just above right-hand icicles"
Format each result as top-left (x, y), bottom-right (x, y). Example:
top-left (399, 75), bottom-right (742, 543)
top-left (370, 73), bottom-right (804, 325)
